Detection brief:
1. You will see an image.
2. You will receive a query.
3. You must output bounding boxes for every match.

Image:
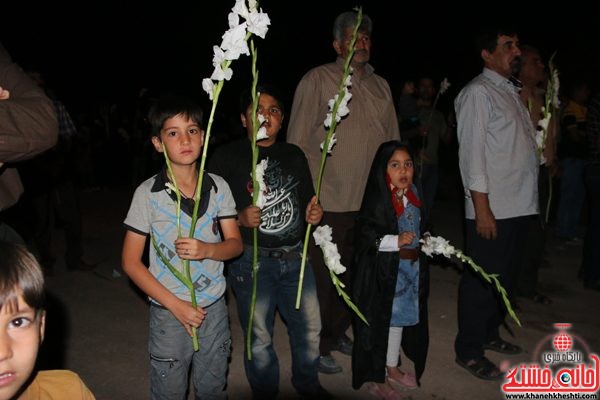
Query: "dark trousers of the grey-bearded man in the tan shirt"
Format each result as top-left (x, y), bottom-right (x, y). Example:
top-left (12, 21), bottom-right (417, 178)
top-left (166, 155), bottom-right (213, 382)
top-left (309, 212), bottom-right (356, 355)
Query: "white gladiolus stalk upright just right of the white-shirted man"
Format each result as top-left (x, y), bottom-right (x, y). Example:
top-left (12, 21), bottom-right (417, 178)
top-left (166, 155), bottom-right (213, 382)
top-left (535, 53), bottom-right (560, 223)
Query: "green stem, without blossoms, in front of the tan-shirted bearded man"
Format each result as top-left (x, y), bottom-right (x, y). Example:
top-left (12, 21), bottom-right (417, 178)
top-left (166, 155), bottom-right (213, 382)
top-left (296, 7), bottom-right (362, 309)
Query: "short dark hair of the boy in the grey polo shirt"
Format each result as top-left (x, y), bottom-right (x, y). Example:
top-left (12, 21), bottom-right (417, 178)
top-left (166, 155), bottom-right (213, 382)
top-left (148, 94), bottom-right (204, 136)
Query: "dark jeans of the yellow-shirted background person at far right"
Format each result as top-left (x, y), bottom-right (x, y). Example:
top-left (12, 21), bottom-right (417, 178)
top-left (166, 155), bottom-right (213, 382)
top-left (556, 158), bottom-right (585, 239)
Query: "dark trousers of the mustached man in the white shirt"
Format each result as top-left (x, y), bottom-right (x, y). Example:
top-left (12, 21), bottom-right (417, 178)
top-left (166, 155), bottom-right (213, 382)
top-left (455, 216), bottom-right (530, 360)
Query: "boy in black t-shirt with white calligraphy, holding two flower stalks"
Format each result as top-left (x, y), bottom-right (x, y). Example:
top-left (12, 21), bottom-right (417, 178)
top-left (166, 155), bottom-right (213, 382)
top-left (208, 85), bottom-right (330, 399)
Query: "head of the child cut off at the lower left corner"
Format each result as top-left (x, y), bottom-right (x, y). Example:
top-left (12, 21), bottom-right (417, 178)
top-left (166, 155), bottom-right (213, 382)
top-left (0, 241), bottom-right (45, 400)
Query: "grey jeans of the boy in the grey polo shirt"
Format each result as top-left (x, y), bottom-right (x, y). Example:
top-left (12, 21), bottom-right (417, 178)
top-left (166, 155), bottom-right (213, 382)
top-left (148, 297), bottom-right (231, 400)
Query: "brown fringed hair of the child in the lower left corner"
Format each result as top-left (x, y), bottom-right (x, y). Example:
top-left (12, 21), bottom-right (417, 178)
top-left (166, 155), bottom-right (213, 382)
top-left (0, 241), bottom-right (45, 311)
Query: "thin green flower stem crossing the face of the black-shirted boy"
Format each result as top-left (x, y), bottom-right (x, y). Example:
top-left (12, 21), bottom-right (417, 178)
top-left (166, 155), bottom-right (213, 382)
top-left (246, 40), bottom-right (260, 360)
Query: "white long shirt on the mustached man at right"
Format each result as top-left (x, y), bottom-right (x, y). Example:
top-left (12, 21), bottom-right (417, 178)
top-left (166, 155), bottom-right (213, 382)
top-left (454, 68), bottom-right (539, 219)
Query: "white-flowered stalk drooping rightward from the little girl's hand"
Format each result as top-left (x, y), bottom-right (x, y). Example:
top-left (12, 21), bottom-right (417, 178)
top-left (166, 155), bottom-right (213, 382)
top-left (420, 234), bottom-right (521, 326)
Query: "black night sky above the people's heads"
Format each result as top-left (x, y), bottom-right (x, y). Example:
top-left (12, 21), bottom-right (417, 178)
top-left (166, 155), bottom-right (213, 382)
top-left (0, 0), bottom-right (600, 123)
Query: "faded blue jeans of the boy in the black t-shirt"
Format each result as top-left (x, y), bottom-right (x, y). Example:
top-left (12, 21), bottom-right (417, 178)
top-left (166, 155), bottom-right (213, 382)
top-left (228, 247), bottom-right (321, 399)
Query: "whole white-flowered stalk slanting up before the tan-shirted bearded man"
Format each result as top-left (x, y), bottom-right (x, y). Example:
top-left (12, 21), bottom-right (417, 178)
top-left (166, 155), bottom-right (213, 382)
top-left (296, 7), bottom-right (362, 309)
